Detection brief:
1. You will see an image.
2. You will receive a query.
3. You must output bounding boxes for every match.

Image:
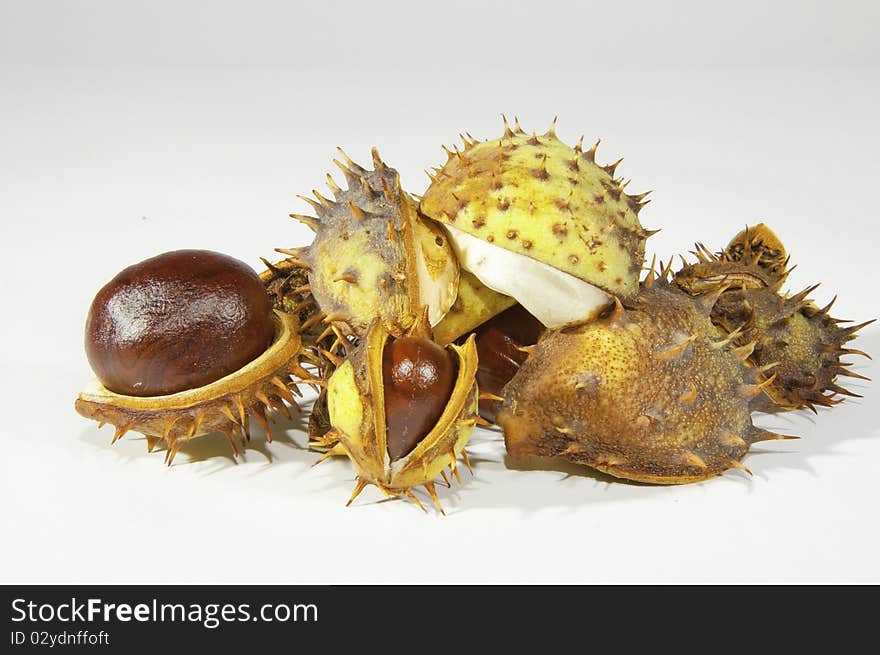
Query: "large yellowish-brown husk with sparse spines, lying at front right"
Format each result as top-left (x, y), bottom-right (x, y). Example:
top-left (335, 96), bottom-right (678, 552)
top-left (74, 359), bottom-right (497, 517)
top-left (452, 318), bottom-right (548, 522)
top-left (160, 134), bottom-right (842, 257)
top-left (497, 277), bottom-right (781, 484)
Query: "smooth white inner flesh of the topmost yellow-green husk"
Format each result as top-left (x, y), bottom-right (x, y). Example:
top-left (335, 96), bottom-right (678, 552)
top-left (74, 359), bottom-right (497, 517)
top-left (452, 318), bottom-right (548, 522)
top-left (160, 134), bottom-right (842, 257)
top-left (443, 225), bottom-right (611, 329)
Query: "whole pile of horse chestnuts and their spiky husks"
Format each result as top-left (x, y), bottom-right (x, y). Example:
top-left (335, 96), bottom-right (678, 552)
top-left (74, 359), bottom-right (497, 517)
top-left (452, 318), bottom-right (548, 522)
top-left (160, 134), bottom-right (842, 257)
top-left (76, 119), bottom-right (870, 512)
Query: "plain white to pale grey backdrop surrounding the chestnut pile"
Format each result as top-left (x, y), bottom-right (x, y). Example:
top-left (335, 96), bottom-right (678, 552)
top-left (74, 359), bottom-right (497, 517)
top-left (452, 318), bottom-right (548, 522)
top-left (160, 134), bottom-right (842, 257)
top-left (0, 0), bottom-right (880, 583)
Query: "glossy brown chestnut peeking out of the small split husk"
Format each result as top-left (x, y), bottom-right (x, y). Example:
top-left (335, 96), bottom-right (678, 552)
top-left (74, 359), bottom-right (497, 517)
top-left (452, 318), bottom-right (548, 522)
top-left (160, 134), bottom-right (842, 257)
top-left (382, 337), bottom-right (456, 461)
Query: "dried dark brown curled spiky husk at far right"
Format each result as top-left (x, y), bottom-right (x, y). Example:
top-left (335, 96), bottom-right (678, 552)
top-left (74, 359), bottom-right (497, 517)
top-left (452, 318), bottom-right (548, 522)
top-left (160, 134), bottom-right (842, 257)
top-left (674, 224), bottom-right (870, 411)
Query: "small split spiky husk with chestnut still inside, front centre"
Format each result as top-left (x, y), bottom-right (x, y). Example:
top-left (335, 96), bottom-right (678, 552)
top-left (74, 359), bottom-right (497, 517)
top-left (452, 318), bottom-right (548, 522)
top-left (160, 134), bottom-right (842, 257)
top-left (319, 320), bottom-right (479, 512)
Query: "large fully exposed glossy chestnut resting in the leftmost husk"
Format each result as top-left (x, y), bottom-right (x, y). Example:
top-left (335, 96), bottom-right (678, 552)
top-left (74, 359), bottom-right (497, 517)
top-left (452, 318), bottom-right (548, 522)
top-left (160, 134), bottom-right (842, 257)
top-left (85, 250), bottom-right (274, 396)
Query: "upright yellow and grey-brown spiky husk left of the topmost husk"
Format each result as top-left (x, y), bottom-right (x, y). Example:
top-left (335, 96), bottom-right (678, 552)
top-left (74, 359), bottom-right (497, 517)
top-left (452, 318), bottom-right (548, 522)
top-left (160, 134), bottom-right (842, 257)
top-left (279, 148), bottom-right (458, 336)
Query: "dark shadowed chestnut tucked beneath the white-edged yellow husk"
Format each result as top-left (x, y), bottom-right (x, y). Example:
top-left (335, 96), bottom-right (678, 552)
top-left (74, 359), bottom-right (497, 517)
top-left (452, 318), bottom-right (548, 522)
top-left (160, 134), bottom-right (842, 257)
top-left (476, 305), bottom-right (544, 421)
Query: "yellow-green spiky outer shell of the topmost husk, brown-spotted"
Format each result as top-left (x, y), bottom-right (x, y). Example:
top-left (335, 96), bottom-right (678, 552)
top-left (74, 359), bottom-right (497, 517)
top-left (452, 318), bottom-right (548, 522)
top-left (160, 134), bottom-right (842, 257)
top-left (420, 120), bottom-right (651, 296)
